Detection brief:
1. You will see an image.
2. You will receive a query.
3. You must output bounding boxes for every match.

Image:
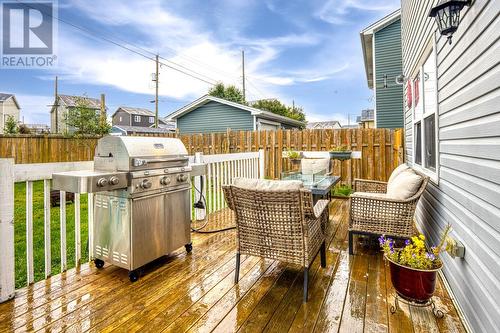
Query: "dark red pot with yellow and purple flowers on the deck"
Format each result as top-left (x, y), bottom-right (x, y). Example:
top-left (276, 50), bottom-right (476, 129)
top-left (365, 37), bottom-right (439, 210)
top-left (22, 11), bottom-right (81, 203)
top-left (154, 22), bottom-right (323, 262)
top-left (379, 225), bottom-right (450, 303)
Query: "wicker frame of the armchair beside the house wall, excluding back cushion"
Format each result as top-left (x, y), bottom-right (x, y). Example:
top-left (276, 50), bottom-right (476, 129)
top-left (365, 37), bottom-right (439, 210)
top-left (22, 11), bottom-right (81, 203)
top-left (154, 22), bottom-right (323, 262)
top-left (349, 170), bottom-right (429, 254)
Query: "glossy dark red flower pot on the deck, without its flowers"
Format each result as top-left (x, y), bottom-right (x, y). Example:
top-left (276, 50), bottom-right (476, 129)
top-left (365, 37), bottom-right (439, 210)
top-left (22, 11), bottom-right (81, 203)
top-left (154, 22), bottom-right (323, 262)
top-left (385, 257), bottom-right (441, 303)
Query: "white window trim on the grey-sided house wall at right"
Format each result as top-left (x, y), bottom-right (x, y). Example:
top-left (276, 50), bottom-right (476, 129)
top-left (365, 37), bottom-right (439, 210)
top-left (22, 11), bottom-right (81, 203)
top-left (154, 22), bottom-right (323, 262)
top-left (410, 39), bottom-right (440, 185)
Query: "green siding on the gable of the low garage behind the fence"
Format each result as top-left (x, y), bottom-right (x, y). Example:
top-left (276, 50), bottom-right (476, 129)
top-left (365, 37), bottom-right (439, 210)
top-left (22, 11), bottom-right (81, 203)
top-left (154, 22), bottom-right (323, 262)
top-left (177, 101), bottom-right (253, 133)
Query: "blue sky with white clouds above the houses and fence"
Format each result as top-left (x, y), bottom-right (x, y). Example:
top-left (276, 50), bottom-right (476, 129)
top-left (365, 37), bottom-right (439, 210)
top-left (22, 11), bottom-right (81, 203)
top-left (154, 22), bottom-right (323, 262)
top-left (0, 0), bottom-right (400, 123)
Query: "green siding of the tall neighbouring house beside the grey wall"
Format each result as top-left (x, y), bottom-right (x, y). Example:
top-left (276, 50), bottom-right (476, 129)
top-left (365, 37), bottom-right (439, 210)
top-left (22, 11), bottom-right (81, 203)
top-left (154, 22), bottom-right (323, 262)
top-left (374, 20), bottom-right (404, 128)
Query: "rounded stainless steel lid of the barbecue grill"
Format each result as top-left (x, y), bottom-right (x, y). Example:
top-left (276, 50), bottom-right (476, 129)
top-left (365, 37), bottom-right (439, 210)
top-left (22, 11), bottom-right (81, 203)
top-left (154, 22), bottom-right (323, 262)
top-left (94, 136), bottom-right (187, 171)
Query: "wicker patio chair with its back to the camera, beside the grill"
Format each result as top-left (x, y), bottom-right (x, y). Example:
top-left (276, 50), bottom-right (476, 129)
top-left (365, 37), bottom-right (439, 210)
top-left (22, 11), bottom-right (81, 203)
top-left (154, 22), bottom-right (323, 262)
top-left (223, 179), bottom-right (329, 302)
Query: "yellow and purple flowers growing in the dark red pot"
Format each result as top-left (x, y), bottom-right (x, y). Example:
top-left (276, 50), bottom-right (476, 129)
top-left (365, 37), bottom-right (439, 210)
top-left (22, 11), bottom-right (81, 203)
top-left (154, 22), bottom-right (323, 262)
top-left (379, 225), bottom-right (451, 269)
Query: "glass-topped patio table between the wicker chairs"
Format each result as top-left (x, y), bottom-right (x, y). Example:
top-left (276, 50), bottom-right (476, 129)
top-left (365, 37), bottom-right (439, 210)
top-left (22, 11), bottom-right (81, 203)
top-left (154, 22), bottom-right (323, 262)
top-left (281, 172), bottom-right (340, 202)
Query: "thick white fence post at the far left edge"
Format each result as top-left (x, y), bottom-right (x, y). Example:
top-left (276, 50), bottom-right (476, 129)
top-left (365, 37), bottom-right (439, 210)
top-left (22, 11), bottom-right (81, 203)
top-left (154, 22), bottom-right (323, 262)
top-left (0, 158), bottom-right (15, 303)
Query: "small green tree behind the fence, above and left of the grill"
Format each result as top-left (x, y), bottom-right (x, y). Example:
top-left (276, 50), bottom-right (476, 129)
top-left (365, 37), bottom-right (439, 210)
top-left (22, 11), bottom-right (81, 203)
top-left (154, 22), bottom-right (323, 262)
top-left (65, 97), bottom-right (111, 135)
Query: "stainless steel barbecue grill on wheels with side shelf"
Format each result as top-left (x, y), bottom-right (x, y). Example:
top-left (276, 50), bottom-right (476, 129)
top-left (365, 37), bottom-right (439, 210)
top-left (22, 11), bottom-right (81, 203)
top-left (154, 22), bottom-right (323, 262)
top-left (52, 136), bottom-right (192, 281)
